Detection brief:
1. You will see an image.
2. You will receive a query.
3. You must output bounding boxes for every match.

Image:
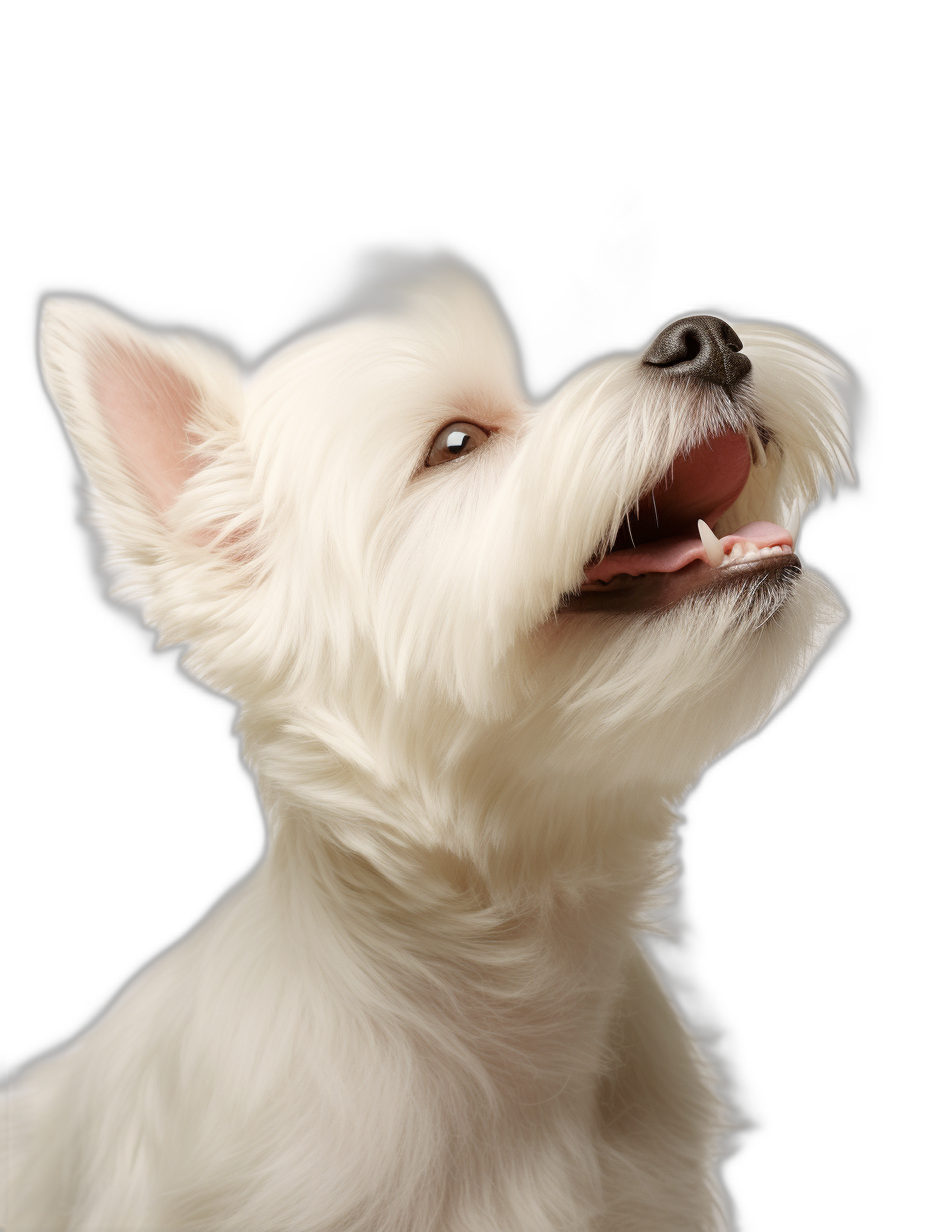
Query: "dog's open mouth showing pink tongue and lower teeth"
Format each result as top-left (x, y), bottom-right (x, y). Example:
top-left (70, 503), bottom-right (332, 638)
top-left (563, 431), bottom-right (799, 611)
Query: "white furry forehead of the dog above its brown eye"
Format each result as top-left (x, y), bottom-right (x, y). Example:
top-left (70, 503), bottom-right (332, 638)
top-left (244, 276), bottom-right (526, 482)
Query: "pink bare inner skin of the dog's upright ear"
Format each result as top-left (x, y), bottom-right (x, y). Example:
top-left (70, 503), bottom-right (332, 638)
top-left (95, 341), bottom-right (200, 513)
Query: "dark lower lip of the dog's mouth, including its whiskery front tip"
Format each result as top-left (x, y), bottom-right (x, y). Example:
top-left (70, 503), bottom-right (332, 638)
top-left (560, 552), bottom-right (802, 612)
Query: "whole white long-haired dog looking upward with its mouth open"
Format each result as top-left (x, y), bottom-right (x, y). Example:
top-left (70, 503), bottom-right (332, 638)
top-left (7, 257), bottom-right (853, 1232)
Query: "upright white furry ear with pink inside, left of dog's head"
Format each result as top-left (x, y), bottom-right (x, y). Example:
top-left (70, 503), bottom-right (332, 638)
top-left (38, 296), bottom-right (242, 557)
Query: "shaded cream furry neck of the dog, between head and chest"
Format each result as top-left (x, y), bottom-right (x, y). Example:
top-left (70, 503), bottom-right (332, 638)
top-left (253, 793), bottom-right (673, 1099)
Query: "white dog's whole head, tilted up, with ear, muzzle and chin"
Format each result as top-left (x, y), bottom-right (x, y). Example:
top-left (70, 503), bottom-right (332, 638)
top-left (39, 257), bottom-right (852, 872)
